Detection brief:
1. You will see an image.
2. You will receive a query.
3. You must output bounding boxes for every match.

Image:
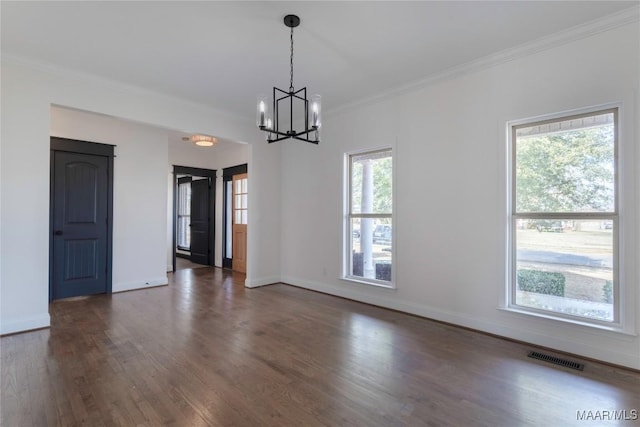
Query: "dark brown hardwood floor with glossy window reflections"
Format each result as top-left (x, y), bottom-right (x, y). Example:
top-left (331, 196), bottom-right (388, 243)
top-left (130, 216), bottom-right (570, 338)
top-left (0, 267), bottom-right (640, 427)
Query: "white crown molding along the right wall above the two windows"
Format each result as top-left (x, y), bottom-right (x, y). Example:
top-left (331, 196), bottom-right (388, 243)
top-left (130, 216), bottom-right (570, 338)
top-left (323, 5), bottom-right (640, 116)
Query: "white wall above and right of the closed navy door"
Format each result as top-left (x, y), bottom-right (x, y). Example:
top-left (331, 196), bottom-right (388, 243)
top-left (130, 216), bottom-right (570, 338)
top-left (51, 107), bottom-right (168, 292)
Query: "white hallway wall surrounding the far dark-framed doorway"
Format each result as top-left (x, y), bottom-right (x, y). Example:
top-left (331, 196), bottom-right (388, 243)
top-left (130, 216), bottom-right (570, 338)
top-left (167, 143), bottom-right (251, 271)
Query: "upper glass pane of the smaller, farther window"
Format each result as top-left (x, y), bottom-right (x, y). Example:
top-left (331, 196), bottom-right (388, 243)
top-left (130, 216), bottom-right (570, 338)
top-left (350, 151), bottom-right (393, 214)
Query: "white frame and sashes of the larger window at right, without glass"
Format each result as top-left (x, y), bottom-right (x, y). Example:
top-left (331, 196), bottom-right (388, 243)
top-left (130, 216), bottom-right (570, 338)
top-left (502, 104), bottom-right (620, 333)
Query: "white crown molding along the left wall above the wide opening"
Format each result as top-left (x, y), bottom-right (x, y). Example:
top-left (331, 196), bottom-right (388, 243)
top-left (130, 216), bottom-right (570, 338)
top-left (1, 52), bottom-right (247, 121)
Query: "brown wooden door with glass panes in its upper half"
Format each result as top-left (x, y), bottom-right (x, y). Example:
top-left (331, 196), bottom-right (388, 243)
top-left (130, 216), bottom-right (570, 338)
top-left (231, 173), bottom-right (249, 273)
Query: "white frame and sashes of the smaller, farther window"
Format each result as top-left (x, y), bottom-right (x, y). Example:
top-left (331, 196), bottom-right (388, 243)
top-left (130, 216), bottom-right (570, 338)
top-left (341, 145), bottom-right (397, 290)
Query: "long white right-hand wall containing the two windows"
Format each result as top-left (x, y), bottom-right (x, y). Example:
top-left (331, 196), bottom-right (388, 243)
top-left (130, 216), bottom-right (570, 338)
top-left (281, 22), bottom-right (640, 369)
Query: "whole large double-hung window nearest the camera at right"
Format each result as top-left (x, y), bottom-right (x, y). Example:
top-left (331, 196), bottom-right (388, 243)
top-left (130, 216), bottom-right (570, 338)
top-left (509, 108), bottom-right (620, 325)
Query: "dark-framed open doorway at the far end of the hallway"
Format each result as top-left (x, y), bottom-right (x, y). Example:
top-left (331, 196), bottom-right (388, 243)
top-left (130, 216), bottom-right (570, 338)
top-left (172, 165), bottom-right (216, 271)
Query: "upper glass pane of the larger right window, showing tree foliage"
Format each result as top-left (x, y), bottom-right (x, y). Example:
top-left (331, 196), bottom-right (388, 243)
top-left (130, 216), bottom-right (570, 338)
top-left (515, 112), bottom-right (615, 212)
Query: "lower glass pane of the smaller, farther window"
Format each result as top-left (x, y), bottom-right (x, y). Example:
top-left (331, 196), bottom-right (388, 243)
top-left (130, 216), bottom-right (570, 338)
top-left (350, 218), bottom-right (392, 282)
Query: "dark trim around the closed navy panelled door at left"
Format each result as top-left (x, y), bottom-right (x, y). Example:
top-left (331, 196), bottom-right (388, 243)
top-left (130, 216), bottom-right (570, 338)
top-left (49, 136), bottom-right (116, 302)
